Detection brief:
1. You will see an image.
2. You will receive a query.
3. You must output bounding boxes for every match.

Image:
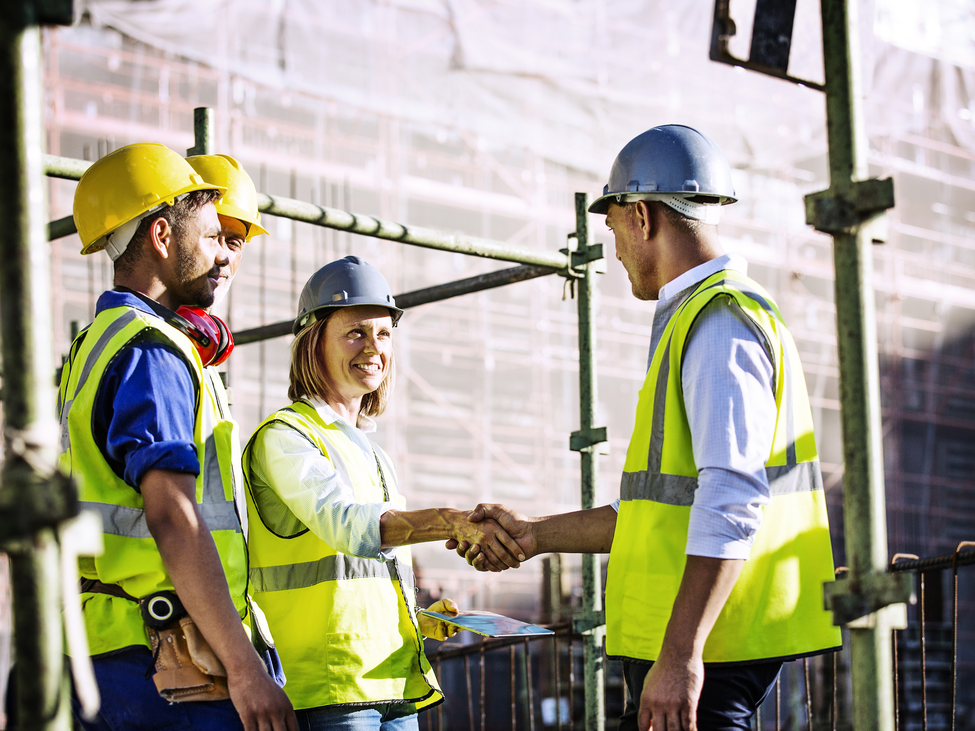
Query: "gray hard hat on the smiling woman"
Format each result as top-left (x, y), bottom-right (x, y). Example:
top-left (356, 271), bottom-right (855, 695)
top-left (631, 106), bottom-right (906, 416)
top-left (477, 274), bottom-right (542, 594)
top-left (291, 256), bottom-right (403, 335)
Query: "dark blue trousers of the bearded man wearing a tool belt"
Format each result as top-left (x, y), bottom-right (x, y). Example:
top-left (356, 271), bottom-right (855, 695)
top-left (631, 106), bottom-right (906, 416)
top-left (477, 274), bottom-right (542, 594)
top-left (72, 647), bottom-right (244, 731)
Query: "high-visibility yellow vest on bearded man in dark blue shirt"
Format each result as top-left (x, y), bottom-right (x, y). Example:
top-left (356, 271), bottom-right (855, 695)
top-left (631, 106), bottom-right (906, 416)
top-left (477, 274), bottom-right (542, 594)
top-left (58, 307), bottom-right (247, 655)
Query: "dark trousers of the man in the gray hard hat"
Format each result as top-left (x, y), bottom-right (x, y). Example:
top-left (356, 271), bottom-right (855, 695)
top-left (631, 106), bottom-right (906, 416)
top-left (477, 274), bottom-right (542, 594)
top-left (620, 660), bottom-right (782, 731)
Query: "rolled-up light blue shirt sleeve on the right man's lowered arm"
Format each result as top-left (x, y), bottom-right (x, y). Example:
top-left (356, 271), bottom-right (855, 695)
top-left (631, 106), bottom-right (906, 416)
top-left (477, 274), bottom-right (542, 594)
top-left (681, 297), bottom-right (777, 559)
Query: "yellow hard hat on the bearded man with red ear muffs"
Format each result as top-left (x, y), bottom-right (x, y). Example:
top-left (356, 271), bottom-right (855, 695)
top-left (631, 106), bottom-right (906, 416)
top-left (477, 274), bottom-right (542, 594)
top-left (74, 142), bottom-right (226, 259)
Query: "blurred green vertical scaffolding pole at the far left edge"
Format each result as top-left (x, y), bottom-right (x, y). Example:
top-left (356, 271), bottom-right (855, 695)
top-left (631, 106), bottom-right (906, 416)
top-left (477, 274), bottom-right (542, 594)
top-left (0, 0), bottom-right (71, 731)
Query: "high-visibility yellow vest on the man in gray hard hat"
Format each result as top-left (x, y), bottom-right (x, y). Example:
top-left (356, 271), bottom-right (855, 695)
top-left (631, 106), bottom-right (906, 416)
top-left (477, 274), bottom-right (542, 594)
top-left (606, 270), bottom-right (841, 663)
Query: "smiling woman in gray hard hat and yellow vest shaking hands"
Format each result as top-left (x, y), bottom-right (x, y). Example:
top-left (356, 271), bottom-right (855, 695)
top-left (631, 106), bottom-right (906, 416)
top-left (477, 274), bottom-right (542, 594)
top-left (243, 256), bottom-right (521, 731)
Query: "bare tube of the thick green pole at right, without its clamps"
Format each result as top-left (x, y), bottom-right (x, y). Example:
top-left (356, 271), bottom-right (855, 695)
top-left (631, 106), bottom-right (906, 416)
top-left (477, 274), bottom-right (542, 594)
top-left (821, 0), bottom-right (894, 731)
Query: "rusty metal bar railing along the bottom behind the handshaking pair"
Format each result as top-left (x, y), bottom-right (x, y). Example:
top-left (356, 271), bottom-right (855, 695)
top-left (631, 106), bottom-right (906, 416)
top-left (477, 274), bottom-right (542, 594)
top-left (420, 541), bottom-right (975, 731)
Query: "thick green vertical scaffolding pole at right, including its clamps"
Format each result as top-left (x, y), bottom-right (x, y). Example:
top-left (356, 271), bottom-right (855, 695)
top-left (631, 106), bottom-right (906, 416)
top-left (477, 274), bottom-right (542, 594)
top-left (806, 0), bottom-right (912, 731)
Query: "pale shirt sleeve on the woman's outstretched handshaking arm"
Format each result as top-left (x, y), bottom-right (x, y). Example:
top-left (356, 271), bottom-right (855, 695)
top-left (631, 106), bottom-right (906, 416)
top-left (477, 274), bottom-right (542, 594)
top-left (250, 424), bottom-right (396, 560)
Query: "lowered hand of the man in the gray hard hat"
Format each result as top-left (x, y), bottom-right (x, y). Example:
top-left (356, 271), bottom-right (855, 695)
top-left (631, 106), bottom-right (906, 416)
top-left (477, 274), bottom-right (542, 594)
top-left (637, 656), bottom-right (704, 731)
